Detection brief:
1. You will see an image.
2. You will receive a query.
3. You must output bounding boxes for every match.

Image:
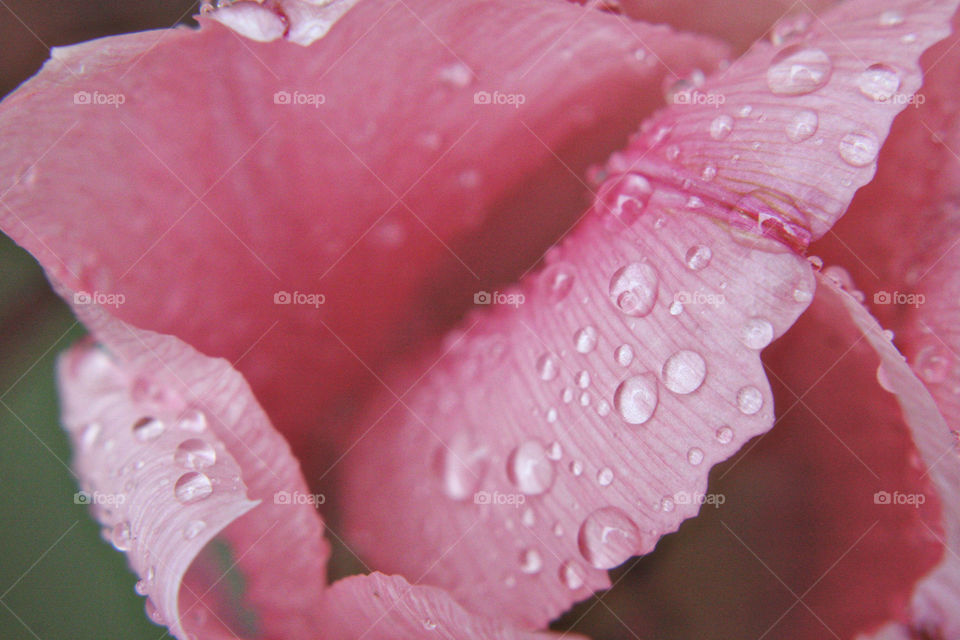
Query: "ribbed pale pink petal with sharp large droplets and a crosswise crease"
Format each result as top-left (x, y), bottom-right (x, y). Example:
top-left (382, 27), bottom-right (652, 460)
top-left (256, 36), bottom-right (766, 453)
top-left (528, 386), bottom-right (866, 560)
top-left (341, 2), bottom-right (954, 626)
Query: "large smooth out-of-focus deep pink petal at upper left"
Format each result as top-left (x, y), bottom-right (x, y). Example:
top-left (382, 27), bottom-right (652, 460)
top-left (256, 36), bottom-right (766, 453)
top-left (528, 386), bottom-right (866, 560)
top-left (0, 0), bottom-right (726, 456)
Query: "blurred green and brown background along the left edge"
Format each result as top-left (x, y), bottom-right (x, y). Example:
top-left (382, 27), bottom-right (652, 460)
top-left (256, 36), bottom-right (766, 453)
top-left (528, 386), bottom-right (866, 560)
top-left (0, 0), bottom-right (197, 640)
